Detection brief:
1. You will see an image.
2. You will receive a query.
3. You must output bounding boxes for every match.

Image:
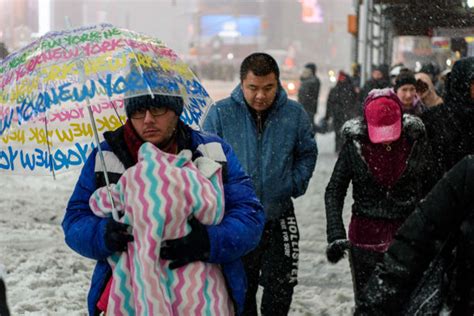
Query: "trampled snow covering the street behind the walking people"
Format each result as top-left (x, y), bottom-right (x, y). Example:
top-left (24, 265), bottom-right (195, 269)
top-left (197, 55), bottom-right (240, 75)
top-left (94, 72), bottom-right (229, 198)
top-left (0, 81), bottom-right (353, 316)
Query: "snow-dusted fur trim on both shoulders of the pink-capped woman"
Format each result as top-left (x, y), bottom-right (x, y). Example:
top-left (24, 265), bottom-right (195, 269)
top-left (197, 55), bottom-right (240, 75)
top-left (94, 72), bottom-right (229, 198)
top-left (342, 113), bottom-right (426, 141)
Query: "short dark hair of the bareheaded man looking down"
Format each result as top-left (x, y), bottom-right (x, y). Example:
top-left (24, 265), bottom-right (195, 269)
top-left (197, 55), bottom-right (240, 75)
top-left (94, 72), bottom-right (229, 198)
top-left (240, 53), bottom-right (280, 81)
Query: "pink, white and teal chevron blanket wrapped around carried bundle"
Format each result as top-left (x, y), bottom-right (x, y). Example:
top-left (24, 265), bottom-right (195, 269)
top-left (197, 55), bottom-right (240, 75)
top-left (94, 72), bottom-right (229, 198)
top-left (89, 143), bottom-right (234, 316)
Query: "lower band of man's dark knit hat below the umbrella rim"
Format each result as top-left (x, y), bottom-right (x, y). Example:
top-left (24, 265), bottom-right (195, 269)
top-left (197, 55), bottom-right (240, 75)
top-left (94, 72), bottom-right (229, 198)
top-left (125, 94), bottom-right (184, 117)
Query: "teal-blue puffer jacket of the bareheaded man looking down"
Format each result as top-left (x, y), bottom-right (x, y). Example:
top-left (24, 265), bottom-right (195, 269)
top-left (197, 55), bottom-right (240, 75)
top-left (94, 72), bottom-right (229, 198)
top-left (204, 85), bottom-right (318, 220)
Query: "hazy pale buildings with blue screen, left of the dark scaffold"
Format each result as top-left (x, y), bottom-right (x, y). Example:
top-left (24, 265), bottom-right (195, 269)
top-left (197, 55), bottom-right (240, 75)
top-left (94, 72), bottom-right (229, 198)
top-left (0, 0), bottom-right (353, 87)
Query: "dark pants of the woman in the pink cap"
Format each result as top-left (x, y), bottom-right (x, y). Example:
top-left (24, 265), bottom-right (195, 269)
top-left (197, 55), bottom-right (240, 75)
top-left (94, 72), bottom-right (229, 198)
top-left (349, 246), bottom-right (384, 305)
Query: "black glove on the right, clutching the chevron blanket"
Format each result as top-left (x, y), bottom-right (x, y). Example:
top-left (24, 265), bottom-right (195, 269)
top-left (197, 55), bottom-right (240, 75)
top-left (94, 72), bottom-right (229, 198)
top-left (160, 217), bottom-right (211, 270)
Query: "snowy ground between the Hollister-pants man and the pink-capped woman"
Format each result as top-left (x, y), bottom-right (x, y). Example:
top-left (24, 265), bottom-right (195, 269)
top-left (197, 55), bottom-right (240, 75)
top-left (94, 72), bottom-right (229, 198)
top-left (290, 133), bottom-right (354, 316)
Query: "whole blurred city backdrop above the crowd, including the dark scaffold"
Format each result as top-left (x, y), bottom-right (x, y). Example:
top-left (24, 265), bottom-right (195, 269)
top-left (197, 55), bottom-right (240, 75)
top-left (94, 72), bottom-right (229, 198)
top-left (0, 0), bottom-right (474, 86)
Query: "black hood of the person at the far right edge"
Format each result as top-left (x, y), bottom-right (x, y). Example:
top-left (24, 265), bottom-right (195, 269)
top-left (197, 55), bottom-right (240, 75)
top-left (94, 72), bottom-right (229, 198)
top-left (445, 57), bottom-right (474, 106)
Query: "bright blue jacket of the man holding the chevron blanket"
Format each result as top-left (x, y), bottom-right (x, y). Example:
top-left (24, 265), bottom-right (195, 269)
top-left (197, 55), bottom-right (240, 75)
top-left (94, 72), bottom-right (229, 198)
top-left (62, 123), bottom-right (265, 315)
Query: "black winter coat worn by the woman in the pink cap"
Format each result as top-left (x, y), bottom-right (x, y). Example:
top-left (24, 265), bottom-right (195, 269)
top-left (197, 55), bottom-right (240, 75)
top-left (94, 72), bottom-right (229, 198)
top-left (324, 114), bottom-right (434, 243)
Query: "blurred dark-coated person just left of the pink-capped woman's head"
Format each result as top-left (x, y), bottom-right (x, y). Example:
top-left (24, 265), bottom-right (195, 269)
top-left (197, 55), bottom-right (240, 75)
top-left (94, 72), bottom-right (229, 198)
top-left (325, 71), bottom-right (359, 153)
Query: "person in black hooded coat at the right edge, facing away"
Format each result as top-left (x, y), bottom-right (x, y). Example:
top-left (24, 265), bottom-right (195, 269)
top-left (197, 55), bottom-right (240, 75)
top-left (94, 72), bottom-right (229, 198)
top-left (422, 57), bottom-right (474, 177)
